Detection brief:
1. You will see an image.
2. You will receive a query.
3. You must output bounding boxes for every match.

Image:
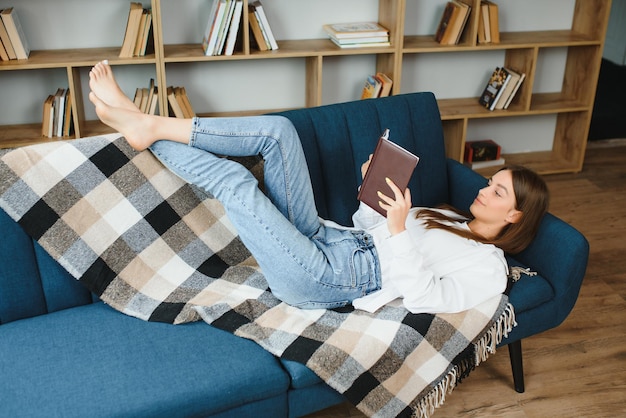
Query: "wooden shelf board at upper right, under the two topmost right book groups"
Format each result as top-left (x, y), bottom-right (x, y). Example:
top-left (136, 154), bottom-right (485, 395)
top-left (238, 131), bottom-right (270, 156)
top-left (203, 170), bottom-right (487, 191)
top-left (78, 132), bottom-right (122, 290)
top-left (403, 30), bottom-right (602, 52)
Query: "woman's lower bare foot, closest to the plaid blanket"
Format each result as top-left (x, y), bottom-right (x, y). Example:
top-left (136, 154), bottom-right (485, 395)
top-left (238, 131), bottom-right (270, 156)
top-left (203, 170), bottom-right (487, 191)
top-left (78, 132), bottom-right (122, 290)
top-left (89, 91), bottom-right (157, 151)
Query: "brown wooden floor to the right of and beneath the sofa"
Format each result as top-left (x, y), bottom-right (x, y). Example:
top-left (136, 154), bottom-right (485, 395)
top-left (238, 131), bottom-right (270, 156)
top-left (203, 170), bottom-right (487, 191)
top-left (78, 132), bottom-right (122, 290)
top-left (308, 140), bottom-right (626, 418)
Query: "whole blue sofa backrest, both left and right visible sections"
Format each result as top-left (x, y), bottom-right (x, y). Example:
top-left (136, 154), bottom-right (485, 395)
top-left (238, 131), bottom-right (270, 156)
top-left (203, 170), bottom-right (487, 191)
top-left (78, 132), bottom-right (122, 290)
top-left (0, 93), bottom-right (449, 324)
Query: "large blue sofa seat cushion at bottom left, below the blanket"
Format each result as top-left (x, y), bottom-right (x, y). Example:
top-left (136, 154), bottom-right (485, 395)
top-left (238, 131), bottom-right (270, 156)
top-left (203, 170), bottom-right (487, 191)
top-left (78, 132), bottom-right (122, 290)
top-left (0, 303), bottom-right (289, 417)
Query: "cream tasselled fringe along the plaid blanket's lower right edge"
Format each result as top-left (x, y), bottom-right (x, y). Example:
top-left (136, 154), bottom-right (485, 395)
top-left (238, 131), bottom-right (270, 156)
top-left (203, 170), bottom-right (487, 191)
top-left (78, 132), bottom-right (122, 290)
top-left (412, 303), bottom-right (517, 418)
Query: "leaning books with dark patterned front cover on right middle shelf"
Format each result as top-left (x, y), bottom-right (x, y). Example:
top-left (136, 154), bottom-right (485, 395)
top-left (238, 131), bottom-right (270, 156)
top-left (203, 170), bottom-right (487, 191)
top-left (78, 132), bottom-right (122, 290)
top-left (478, 67), bottom-right (526, 110)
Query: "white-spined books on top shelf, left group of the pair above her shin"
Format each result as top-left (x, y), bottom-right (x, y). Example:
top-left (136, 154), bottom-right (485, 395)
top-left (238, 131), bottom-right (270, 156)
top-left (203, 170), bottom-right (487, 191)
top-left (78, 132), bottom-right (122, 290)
top-left (202, 0), bottom-right (243, 55)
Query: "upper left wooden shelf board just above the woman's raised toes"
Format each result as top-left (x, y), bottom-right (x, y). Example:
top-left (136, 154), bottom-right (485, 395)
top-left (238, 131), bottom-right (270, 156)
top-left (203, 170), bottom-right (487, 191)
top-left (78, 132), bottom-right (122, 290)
top-left (0, 47), bottom-right (156, 71)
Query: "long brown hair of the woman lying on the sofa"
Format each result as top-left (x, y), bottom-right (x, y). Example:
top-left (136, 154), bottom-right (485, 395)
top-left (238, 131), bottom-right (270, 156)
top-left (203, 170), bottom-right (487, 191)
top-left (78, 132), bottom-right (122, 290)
top-left (416, 165), bottom-right (550, 254)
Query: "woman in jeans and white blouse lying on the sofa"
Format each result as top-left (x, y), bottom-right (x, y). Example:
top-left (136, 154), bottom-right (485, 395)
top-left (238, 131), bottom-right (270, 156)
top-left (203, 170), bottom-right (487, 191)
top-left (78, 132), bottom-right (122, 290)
top-left (89, 62), bottom-right (548, 313)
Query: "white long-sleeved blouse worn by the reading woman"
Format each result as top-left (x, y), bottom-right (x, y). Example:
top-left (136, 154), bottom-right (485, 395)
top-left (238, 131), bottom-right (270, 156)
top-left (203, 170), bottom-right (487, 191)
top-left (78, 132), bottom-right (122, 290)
top-left (352, 203), bottom-right (508, 313)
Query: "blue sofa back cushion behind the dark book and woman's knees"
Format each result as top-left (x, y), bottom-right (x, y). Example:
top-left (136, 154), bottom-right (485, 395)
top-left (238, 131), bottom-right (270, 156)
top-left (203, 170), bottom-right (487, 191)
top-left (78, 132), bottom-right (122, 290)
top-left (278, 93), bottom-right (449, 225)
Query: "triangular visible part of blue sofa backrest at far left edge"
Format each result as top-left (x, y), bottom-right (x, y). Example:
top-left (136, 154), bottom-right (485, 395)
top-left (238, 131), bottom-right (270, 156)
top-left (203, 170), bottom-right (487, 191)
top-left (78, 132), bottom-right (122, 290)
top-left (0, 209), bottom-right (93, 324)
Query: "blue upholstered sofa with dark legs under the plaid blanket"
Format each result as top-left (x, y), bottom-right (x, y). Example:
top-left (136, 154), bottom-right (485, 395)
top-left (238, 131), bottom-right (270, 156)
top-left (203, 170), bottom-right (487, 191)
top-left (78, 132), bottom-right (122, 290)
top-left (0, 93), bottom-right (589, 418)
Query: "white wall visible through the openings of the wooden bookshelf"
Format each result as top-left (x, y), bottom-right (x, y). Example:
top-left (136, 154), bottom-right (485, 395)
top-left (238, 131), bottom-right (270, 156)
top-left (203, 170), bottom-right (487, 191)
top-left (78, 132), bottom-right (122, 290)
top-left (0, 0), bottom-right (574, 152)
